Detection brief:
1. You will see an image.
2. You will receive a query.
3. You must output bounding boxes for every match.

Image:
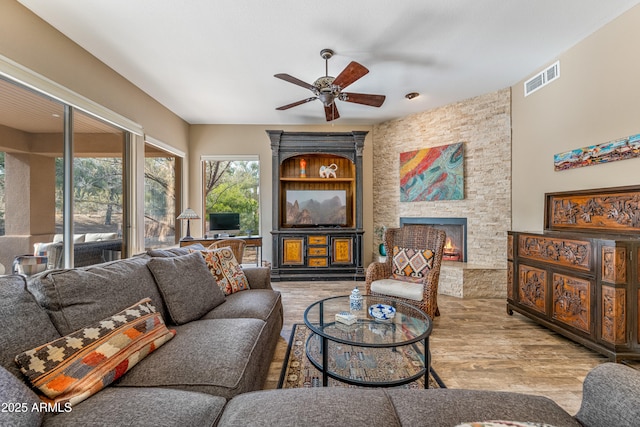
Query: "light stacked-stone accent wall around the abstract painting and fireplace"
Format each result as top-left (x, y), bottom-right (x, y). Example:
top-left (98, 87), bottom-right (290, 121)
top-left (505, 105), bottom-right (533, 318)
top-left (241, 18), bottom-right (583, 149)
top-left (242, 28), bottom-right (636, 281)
top-left (373, 88), bottom-right (511, 268)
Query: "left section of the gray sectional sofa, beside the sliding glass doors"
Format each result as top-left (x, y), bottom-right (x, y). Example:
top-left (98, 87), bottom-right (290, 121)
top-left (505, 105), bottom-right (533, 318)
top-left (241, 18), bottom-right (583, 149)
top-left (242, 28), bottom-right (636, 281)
top-left (0, 249), bottom-right (282, 426)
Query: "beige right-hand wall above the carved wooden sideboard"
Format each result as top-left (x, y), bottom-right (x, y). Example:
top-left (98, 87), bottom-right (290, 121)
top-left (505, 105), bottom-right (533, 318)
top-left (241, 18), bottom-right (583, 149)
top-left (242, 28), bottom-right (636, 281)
top-left (512, 6), bottom-right (640, 231)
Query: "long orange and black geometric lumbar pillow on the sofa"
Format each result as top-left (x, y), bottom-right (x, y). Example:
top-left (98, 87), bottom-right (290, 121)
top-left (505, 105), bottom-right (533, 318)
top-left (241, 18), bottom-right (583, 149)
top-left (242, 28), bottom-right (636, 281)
top-left (15, 298), bottom-right (175, 410)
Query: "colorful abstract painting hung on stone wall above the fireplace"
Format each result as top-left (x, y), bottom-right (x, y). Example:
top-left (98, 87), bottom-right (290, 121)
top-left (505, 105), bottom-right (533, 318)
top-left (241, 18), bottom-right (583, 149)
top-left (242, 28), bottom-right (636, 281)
top-left (400, 142), bottom-right (464, 202)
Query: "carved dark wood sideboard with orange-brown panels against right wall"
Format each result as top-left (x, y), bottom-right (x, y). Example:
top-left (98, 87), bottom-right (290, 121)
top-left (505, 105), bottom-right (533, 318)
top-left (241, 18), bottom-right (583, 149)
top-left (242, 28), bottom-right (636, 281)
top-left (507, 186), bottom-right (640, 362)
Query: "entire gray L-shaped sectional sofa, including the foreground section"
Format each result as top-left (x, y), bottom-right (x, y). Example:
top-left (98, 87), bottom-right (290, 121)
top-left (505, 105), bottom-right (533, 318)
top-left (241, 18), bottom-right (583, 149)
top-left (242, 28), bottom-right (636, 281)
top-left (0, 249), bottom-right (640, 427)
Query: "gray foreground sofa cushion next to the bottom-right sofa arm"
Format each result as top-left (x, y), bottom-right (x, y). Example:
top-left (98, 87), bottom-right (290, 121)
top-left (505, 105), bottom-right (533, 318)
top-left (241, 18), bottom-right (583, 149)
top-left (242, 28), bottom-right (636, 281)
top-left (388, 389), bottom-right (580, 427)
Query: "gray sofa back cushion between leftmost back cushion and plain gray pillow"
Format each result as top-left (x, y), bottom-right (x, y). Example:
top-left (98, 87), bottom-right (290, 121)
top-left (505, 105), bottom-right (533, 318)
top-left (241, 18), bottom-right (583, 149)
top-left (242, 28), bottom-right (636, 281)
top-left (28, 257), bottom-right (169, 335)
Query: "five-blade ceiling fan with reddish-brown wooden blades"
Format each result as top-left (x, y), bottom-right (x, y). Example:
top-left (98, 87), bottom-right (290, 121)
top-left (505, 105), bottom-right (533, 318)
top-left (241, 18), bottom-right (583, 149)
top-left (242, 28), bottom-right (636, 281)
top-left (274, 49), bottom-right (385, 122)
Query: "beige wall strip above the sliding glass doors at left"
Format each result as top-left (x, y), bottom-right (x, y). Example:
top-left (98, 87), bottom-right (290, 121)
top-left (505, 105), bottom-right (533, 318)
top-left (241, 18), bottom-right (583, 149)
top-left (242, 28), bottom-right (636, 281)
top-left (0, 0), bottom-right (189, 152)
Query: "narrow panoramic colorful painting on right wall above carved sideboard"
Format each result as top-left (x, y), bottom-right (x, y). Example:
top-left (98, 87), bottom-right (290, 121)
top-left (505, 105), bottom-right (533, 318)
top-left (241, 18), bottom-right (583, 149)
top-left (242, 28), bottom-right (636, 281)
top-left (553, 134), bottom-right (640, 171)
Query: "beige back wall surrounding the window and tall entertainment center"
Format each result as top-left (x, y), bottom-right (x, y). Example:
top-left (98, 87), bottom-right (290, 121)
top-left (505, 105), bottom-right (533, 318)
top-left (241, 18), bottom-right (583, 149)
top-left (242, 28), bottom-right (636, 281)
top-left (189, 124), bottom-right (373, 264)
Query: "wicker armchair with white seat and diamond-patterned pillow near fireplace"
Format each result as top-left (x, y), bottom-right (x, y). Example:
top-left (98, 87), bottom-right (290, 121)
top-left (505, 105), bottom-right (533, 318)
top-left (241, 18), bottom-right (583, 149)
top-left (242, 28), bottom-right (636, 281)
top-left (365, 224), bottom-right (446, 318)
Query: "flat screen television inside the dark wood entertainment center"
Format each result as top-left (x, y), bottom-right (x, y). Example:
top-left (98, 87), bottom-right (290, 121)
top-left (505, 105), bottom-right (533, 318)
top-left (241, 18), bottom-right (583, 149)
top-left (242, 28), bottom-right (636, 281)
top-left (284, 190), bottom-right (347, 227)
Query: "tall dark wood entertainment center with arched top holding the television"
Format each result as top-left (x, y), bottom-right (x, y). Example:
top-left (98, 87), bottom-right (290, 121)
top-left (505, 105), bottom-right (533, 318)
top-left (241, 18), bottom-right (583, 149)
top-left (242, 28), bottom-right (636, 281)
top-left (267, 130), bottom-right (367, 281)
